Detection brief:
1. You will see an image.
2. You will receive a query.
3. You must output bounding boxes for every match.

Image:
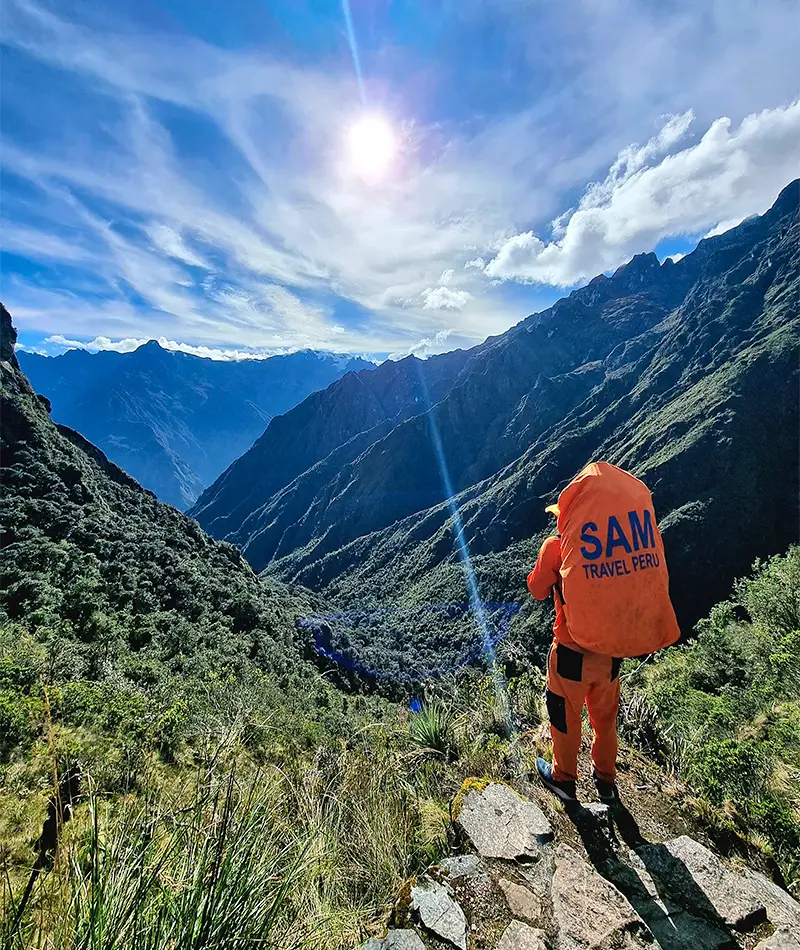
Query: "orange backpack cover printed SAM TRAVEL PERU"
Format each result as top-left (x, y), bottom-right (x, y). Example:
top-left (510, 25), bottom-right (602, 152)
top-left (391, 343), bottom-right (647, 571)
top-left (548, 462), bottom-right (680, 657)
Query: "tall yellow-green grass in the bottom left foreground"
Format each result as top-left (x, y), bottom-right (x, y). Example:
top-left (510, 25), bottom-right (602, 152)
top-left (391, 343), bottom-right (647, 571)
top-left (0, 749), bottom-right (438, 950)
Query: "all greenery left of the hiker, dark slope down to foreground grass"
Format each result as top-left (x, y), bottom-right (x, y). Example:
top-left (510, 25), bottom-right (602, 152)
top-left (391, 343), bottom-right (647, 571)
top-left (0, 322), bottom-right (524, 950)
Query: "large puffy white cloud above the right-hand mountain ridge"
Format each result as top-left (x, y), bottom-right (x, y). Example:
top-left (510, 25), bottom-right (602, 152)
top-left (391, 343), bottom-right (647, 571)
top-left (484, 100), bottom-right (800, 286)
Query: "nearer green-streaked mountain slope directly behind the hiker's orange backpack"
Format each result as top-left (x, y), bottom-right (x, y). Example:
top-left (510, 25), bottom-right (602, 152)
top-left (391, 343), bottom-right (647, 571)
top-left (296, 182), bottom-right (800, 629)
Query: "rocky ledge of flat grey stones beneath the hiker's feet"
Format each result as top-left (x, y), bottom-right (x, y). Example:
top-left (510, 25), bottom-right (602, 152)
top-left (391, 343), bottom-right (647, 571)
top-left (362, 772), bottom-right (800, 950)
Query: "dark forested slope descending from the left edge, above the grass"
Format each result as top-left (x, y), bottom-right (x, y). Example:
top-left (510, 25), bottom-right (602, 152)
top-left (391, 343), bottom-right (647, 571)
top-left (0, 305), bottom-right (322, 687)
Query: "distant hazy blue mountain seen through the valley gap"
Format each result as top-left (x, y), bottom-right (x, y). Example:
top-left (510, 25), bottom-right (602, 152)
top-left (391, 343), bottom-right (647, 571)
top-left (19, 340), bottom-right (372, 508)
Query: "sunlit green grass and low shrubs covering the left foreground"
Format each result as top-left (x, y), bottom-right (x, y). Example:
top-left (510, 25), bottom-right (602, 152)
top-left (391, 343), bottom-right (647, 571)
top-left (0, 644), bottom-right (541, 950)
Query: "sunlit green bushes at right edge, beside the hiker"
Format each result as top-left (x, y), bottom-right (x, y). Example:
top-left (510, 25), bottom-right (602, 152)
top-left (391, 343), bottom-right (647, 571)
top-left (625, 547), bottom-right (800, 884)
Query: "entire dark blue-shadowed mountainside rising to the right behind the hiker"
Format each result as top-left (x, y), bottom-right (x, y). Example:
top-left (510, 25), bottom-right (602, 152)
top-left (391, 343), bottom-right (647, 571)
top-left (191, 182), bottom-right (800, 648)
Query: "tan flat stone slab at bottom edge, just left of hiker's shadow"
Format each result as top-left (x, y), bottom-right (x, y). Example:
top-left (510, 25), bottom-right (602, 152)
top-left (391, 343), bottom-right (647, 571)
top-left (553, 844), bottom-right (653, 950)
